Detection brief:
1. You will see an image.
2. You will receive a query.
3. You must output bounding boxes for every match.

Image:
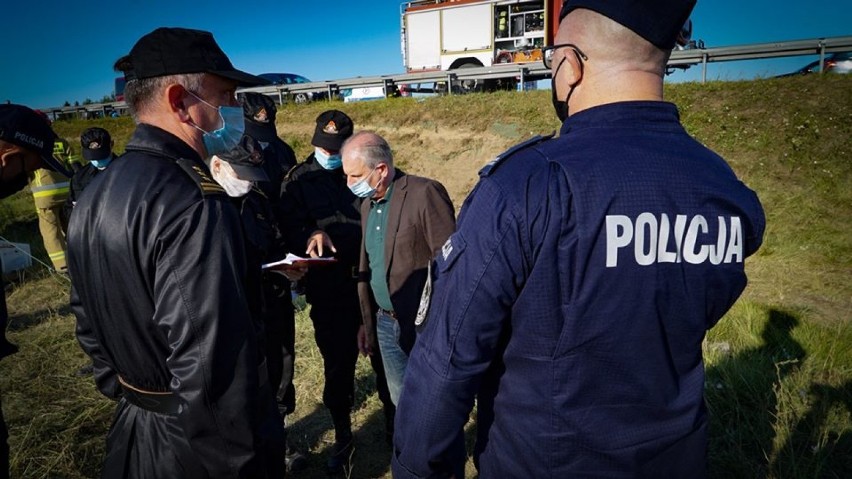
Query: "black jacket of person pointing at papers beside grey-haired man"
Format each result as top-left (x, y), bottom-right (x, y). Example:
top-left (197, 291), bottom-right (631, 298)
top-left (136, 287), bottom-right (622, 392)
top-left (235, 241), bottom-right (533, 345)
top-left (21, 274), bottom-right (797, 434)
top-left (281, 154), bottom-right (361, 303)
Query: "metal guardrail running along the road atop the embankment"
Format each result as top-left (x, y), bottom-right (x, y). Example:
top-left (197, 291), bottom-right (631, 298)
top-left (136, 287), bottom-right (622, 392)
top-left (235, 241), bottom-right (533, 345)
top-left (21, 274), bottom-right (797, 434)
top-left (43, 36), bottom-right (852, 119)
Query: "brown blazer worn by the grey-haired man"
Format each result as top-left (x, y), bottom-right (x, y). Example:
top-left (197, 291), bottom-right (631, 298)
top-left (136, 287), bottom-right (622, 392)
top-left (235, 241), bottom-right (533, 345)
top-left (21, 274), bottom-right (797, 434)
top-left (358, 170), bottom-right (456, 353)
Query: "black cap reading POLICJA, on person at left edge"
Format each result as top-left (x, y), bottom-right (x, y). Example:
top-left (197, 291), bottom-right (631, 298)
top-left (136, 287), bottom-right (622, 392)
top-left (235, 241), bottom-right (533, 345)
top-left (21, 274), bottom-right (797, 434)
top-left (0, 104), bottom-right (71, 177)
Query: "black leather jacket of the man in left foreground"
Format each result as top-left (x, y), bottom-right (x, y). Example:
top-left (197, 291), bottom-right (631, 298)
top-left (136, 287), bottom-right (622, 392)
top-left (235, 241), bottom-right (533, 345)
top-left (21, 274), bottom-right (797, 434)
top-left (68, 124), bottom-right (283, 478)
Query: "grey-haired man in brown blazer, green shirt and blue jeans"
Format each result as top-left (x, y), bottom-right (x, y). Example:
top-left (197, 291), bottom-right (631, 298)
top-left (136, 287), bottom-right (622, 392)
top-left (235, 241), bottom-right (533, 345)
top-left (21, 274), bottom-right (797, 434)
top-left (341, 131), bottom-right (455, 412)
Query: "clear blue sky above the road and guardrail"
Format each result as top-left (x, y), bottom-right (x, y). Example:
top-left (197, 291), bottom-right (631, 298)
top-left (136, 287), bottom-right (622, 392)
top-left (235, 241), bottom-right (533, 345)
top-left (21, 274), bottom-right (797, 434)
top-left (0, 0), bottom-right (852, 108)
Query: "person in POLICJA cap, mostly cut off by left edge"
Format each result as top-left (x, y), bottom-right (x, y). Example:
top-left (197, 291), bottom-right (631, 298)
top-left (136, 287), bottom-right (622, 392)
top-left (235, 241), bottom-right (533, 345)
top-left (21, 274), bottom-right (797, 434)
top-left (0, 104), bottom-right (71, 478)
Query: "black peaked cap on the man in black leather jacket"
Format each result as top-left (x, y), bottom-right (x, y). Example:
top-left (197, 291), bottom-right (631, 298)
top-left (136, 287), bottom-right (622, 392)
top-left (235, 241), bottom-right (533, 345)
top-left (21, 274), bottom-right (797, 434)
top-left (116, 27), bottom-right (269, 86)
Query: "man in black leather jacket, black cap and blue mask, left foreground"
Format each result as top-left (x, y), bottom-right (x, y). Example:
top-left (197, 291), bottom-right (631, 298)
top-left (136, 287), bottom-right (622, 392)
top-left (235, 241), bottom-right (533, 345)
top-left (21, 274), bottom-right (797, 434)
top-left (69, 28), bottom-right (284, 478)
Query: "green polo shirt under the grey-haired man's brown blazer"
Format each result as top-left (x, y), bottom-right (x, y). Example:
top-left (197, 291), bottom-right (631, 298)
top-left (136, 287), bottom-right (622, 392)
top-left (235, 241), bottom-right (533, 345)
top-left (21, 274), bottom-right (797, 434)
top-left (364, 183), bottom-right (393, 311)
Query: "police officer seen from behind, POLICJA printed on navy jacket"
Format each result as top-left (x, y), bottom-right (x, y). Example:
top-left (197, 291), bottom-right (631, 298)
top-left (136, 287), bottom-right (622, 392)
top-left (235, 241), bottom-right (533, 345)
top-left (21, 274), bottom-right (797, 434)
top-left (392, 0), bottom-right (765, 478)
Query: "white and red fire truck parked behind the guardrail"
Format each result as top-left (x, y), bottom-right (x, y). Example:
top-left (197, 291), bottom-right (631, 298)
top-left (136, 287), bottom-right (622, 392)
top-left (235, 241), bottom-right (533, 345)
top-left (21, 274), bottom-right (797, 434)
top-left (400, 0), bottom-right (692, 91)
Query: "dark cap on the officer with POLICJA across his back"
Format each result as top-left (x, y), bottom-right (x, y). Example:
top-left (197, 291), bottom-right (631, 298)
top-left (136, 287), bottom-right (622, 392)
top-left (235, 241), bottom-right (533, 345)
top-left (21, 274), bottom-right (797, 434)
top-left (559, 0), bottom-right (696, 50)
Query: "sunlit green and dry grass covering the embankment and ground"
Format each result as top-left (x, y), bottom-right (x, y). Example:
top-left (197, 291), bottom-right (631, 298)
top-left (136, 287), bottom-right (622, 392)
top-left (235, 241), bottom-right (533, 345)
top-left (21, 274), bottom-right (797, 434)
top-left (0, 75), bottom-right (852, 479)
